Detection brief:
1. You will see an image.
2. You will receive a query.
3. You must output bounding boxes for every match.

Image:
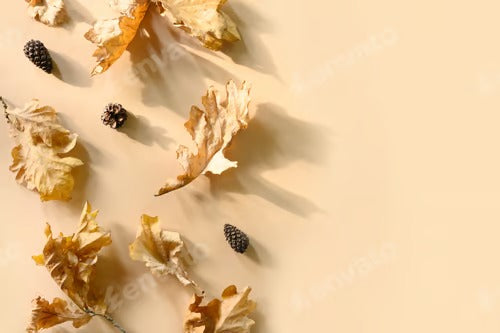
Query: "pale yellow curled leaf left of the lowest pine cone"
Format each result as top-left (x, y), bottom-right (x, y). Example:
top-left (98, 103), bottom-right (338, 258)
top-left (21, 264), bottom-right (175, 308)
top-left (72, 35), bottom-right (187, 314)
top-left (129, 214), bottom-right (198, 290)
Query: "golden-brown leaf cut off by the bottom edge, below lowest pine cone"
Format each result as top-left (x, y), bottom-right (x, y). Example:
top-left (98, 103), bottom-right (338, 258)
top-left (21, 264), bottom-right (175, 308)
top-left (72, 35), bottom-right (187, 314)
top-left (184, 286), bottom-right (256, 333)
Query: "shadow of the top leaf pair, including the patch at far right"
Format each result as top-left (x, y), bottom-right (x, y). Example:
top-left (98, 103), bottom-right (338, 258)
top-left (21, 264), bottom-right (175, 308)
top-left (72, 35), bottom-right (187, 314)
top-left (128, 3), bottom-right (275, 116)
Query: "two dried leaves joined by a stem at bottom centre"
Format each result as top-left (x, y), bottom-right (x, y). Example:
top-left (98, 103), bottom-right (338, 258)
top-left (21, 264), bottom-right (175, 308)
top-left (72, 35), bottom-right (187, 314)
top-left (129, 215), bottom-right (256, 333)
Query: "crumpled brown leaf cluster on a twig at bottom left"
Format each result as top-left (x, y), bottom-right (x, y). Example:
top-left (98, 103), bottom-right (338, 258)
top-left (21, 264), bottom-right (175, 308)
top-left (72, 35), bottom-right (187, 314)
top-left (27, 203), bottom-right (111, 332)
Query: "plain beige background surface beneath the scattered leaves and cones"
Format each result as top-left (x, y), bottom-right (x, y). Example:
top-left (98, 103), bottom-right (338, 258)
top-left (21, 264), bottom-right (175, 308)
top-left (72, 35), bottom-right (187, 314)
top-left (0, 0), bottom-right (500, 333)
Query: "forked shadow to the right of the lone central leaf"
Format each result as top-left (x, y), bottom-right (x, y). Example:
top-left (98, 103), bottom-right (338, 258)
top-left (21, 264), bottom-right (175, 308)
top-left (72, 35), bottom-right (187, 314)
top-left (208, 104), bottom-right (328, 217)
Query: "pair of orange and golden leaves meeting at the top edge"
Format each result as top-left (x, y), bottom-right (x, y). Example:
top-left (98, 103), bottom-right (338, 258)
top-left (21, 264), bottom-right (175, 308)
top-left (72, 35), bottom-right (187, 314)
top-left (85, 0), bottom-right (240, 75)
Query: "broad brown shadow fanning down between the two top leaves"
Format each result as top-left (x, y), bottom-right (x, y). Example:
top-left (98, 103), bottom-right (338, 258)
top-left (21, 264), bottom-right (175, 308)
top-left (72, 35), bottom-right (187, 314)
top-left (128, 10), bottom-right (238, 117)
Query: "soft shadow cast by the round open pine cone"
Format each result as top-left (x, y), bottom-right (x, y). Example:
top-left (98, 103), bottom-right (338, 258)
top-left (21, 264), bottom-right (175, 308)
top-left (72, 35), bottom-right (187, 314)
top-left (118, 112), bottom-right (174, 149)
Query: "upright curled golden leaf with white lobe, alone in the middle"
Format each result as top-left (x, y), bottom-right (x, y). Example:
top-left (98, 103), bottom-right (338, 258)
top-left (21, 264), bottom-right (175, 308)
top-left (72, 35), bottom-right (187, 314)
top-left (157, 81), bottom-right (250, 195)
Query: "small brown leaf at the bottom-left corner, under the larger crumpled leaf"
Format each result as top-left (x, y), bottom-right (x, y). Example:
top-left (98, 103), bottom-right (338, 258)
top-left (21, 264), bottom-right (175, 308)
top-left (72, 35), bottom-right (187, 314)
top-left (27, 297), bottom-right (92, 333)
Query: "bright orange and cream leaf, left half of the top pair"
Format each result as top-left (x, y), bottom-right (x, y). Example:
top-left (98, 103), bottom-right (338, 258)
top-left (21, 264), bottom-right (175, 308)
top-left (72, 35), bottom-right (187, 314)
top-left (85, 0), bottom-right (150, 75)
